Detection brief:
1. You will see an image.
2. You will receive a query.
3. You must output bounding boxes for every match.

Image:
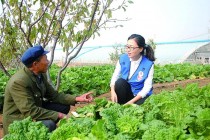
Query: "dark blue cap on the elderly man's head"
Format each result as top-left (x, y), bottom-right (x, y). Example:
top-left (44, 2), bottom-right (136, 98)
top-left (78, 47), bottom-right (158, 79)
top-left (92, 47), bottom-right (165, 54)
top-left (21, 45), bottom-right (49, 65)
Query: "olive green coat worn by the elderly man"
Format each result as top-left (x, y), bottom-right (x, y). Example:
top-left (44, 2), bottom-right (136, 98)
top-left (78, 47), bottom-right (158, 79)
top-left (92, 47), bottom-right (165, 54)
top-left (3, 67), bottom-right (76, 135)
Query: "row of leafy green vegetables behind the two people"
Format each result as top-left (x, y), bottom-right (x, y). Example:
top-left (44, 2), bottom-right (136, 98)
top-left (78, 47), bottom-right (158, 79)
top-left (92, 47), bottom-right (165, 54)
top-left (0, 64), bottom-right (210, 95)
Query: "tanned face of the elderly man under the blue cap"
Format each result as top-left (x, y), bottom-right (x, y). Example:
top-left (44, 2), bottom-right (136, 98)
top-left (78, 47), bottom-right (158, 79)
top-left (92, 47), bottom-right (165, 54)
top-left (35, 55), bottom-right (49, 73)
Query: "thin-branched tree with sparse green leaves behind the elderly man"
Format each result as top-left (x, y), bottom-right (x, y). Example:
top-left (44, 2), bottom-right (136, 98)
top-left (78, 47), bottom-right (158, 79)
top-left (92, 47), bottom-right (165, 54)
top-left (0, 0), bottom-right (132, 90)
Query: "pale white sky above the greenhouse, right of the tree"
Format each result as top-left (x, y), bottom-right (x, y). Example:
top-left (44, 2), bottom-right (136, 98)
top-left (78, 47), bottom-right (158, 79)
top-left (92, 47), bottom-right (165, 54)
top-left (86, 0), bottom-right (210, 46)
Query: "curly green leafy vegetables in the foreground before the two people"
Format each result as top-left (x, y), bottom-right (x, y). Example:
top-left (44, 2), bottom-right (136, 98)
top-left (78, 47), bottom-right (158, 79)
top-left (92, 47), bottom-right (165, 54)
top-left (4, 84), bottom-right (210, 140)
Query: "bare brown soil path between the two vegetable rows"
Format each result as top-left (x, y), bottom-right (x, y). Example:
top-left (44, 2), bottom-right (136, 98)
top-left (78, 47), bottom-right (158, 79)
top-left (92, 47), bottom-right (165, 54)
top-left (0, 78), bottom-right (210, 138)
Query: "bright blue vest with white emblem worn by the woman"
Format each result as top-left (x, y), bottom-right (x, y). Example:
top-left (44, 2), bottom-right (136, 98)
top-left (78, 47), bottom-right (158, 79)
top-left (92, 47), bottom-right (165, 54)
top-left (120, 54), bottom-right (153, 96)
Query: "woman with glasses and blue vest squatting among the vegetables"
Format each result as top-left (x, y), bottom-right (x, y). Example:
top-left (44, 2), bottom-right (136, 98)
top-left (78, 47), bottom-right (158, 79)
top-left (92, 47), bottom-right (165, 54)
top-left (110, 34), bottom-right (155, 105)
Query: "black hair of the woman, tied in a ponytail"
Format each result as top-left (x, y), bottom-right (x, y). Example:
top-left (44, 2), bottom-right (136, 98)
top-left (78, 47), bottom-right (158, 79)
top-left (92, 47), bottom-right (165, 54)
top-left (128, 34), bottom-right (155, 61)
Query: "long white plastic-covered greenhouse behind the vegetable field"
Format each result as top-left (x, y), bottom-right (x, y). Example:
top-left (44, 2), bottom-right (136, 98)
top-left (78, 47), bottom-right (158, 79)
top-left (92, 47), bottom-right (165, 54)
top-left (52, 41), bottom-right (210, 65)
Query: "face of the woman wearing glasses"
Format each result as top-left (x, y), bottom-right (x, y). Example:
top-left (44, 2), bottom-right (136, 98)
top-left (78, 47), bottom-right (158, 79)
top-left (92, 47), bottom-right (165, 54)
top-left (126, 39), bottom-right (143, 61)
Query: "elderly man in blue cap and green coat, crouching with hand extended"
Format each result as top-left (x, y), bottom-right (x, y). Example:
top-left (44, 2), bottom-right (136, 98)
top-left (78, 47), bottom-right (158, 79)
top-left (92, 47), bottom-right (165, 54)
top-left (3, 45), bottom-right (93, 134)
